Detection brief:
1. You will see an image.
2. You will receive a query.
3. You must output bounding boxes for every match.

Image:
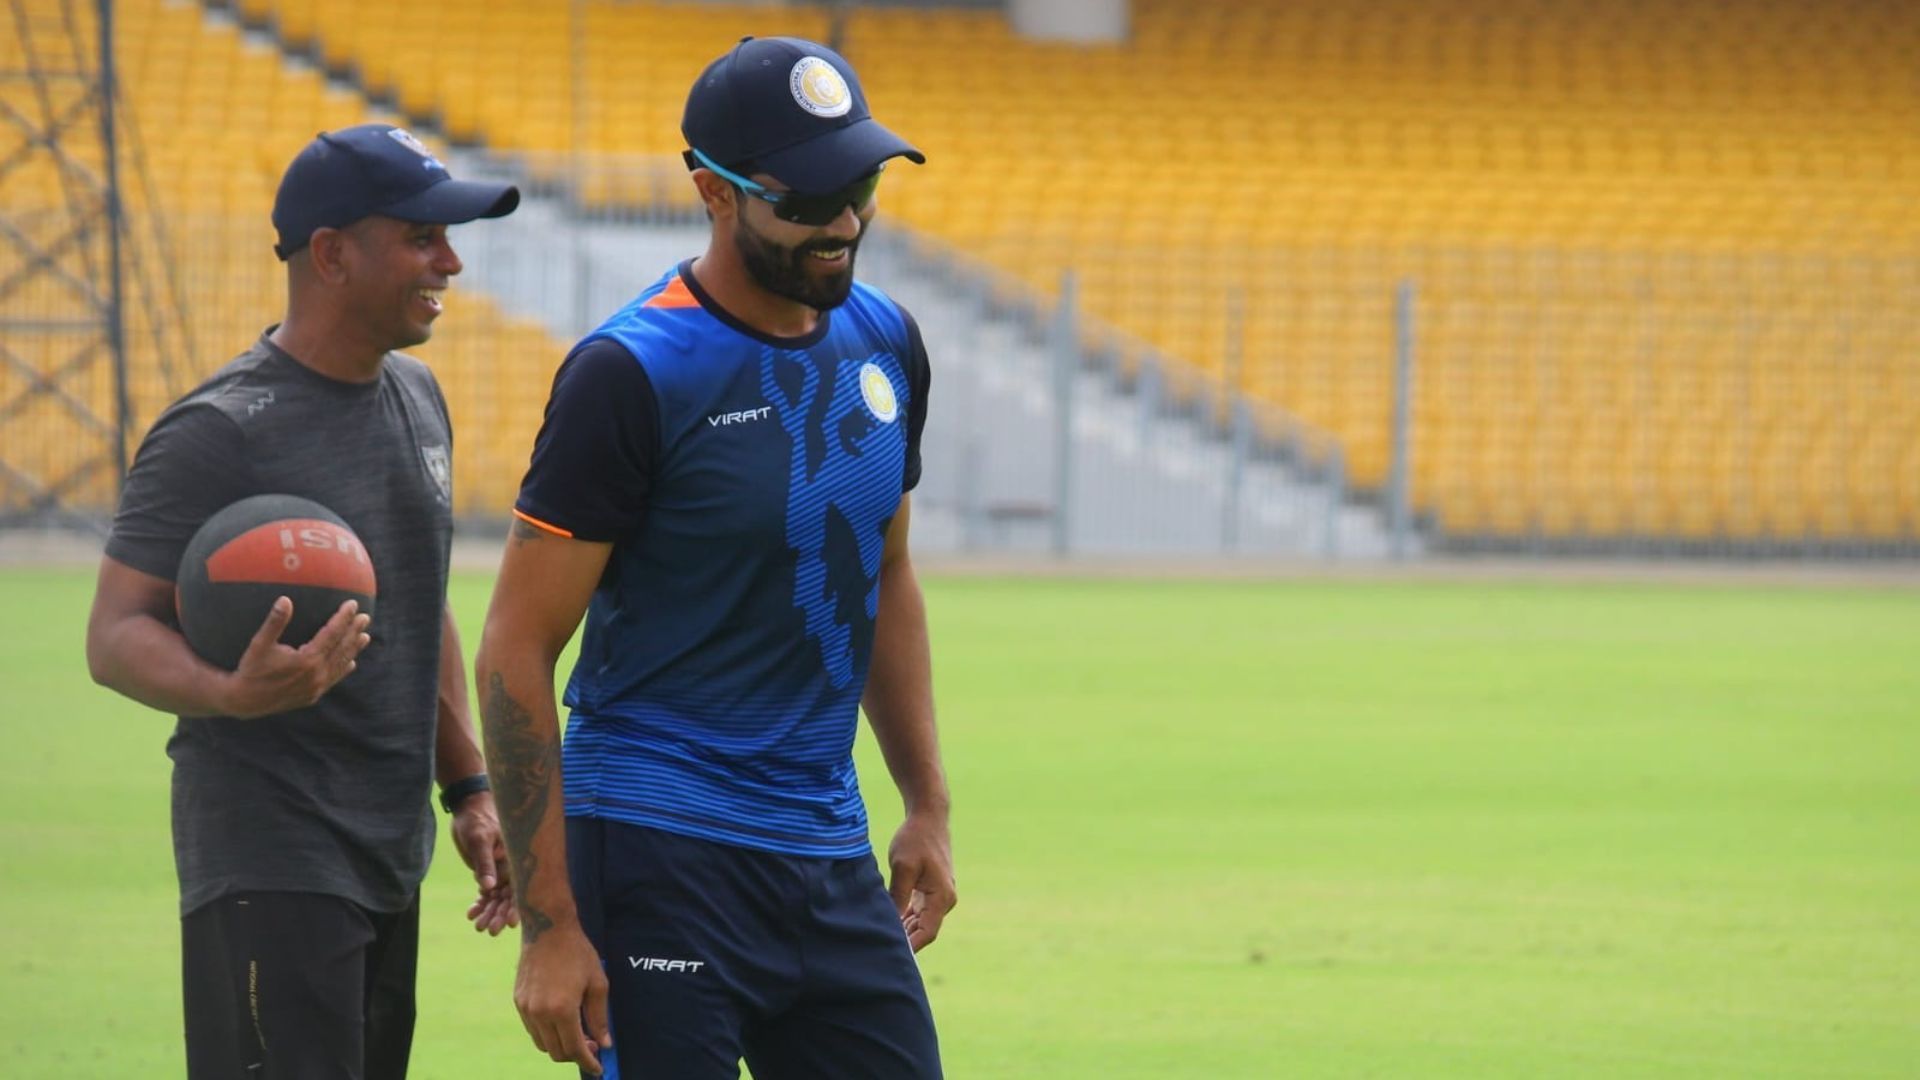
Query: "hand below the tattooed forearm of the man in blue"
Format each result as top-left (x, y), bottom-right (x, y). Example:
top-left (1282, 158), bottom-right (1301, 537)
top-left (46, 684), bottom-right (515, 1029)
top-left (513, 924), bottom-right (612, 1076)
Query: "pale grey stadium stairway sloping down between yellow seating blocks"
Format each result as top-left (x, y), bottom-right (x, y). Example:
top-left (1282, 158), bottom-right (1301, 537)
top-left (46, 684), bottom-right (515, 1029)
top-left (441, 169), bottom-right (1421, 559)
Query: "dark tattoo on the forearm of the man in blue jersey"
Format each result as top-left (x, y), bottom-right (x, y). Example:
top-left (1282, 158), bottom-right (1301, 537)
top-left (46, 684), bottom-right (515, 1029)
top-left (480, 671), bottom-right (561, 944)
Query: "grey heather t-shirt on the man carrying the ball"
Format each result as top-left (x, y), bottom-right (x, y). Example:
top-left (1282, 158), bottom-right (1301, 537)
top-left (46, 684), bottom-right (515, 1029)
top-left (106, 336), bottom-right (453, 915)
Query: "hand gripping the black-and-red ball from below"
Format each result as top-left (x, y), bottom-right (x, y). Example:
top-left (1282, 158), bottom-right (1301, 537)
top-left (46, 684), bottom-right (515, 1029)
top-left (221, 596), bottom-right (372, 721)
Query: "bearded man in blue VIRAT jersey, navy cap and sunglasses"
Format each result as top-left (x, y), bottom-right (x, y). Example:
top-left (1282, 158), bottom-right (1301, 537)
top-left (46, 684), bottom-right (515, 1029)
top-left (474, 38), bottom-right (954, 1080)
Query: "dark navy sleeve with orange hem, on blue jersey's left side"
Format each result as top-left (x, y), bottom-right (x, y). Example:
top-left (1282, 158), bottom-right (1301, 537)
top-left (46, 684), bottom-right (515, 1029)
top-left (513, 338), bottom-right (660, 540)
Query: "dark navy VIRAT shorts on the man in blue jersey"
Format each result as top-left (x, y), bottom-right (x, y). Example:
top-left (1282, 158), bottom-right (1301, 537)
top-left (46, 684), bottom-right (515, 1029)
top-left (566, 817), bottom-right (941, 1080)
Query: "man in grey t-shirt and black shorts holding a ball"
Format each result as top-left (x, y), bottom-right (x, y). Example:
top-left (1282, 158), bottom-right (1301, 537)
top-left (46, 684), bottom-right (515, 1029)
top-left (86, 125), bottom-right (520, 1080)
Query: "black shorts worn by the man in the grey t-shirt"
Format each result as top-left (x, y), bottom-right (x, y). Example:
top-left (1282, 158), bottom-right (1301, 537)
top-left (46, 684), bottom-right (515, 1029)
top-left (180, 892), bottom-right (420, 1080)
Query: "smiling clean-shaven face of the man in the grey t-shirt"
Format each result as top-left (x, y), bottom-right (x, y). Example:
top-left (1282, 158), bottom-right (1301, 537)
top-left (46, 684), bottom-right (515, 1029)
top-left (344, 215), bottom-right (461, 350)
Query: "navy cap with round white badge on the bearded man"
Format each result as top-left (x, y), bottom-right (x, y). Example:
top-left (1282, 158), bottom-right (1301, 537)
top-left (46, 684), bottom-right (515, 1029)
top-left (680, 38), bottom-right (927, 194)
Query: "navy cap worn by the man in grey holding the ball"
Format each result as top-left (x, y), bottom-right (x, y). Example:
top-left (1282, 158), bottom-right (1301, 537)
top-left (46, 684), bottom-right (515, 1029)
top-left (273, 123), bottom-right (520, 259)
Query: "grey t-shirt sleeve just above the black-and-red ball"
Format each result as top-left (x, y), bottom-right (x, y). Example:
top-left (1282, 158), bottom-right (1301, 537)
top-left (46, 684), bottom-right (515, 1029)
top-left (106, 404), bottom-right (250, 580)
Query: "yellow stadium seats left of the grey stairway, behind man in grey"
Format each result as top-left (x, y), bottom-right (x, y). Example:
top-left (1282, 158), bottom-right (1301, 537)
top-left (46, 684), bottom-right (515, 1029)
top-left (0, 0), bottom-right (564, 515)
